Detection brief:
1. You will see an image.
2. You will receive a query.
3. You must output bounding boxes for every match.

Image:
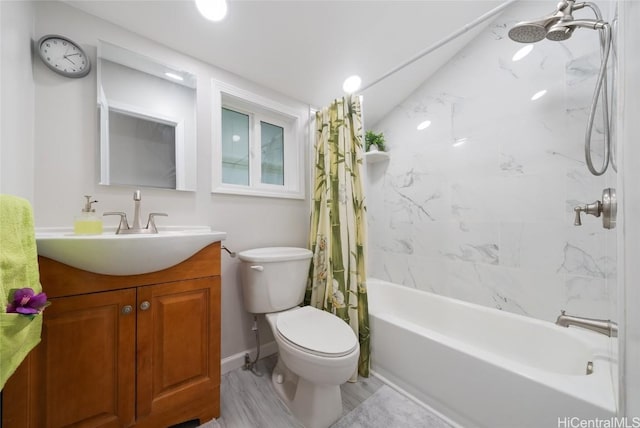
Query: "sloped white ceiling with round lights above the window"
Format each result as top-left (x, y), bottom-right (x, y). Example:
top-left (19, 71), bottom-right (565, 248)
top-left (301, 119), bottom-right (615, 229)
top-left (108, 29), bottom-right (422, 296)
top-left (66, 0), bottom-right (504, 128)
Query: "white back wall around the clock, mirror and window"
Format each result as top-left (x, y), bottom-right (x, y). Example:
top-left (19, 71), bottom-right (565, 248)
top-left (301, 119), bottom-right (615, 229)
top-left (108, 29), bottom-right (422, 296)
top-left (34, 2), bottom-right (309, 364)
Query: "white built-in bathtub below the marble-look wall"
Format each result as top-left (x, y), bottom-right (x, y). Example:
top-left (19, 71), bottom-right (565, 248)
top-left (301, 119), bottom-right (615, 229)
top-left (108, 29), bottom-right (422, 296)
top-left (367, 279), bottom-right (617, 428)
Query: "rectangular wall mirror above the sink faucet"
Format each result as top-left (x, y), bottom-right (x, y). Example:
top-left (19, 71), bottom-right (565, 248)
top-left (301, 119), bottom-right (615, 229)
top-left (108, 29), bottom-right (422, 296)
top-left (97, 41), bottom-right (196, 191)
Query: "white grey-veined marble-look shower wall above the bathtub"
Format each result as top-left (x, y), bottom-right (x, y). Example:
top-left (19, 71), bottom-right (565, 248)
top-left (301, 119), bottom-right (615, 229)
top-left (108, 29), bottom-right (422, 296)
top-left (365, 2), bottom-right (616, 321)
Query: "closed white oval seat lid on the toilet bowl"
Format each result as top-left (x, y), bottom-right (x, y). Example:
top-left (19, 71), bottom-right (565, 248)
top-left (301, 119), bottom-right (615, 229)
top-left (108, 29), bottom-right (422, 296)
top-left (276, 306), bottom-right (358, 356)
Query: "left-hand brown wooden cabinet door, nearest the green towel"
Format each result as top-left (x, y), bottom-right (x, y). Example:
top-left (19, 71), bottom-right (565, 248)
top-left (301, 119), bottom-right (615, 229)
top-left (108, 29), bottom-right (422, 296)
top-left (18, 289), bottom-right (136, 428)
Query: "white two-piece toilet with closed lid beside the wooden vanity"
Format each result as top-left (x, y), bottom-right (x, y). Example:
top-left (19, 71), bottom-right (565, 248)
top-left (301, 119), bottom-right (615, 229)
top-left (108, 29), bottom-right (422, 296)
top-left (238, 247), bottom-right (360, 428)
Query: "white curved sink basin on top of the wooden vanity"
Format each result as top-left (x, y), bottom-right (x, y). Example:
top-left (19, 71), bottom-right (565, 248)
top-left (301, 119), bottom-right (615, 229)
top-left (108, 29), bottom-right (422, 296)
top-left (36, 227), bottom-right (227, 275)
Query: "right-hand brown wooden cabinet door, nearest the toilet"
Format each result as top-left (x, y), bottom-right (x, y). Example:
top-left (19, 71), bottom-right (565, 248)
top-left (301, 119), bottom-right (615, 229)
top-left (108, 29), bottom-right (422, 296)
top-left (136, 277), bottom-right (220, 427)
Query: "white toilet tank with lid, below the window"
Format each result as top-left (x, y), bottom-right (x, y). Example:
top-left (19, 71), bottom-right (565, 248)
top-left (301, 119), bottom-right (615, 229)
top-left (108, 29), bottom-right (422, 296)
top-left (238, 247), bottom-right (313, 314)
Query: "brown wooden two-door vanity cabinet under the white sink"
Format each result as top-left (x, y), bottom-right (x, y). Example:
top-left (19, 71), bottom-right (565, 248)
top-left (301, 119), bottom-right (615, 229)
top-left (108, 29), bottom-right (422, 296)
top-left (2, 242), bottom-right (220, 428)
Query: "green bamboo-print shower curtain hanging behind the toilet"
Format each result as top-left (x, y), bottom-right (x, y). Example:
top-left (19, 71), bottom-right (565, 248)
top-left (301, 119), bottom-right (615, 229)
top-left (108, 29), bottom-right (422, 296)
top-left (305, 96), bottom-right (369, 381)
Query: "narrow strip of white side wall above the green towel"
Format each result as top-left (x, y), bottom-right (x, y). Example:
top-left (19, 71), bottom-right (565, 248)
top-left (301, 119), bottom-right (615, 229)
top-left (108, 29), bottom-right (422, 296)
top-left (0, 1), bottom-right (34, 203)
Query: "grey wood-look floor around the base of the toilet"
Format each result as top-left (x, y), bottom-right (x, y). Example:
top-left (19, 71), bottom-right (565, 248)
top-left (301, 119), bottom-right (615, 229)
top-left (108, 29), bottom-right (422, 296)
top-left (218, 356), bottom-right (383, 428)
